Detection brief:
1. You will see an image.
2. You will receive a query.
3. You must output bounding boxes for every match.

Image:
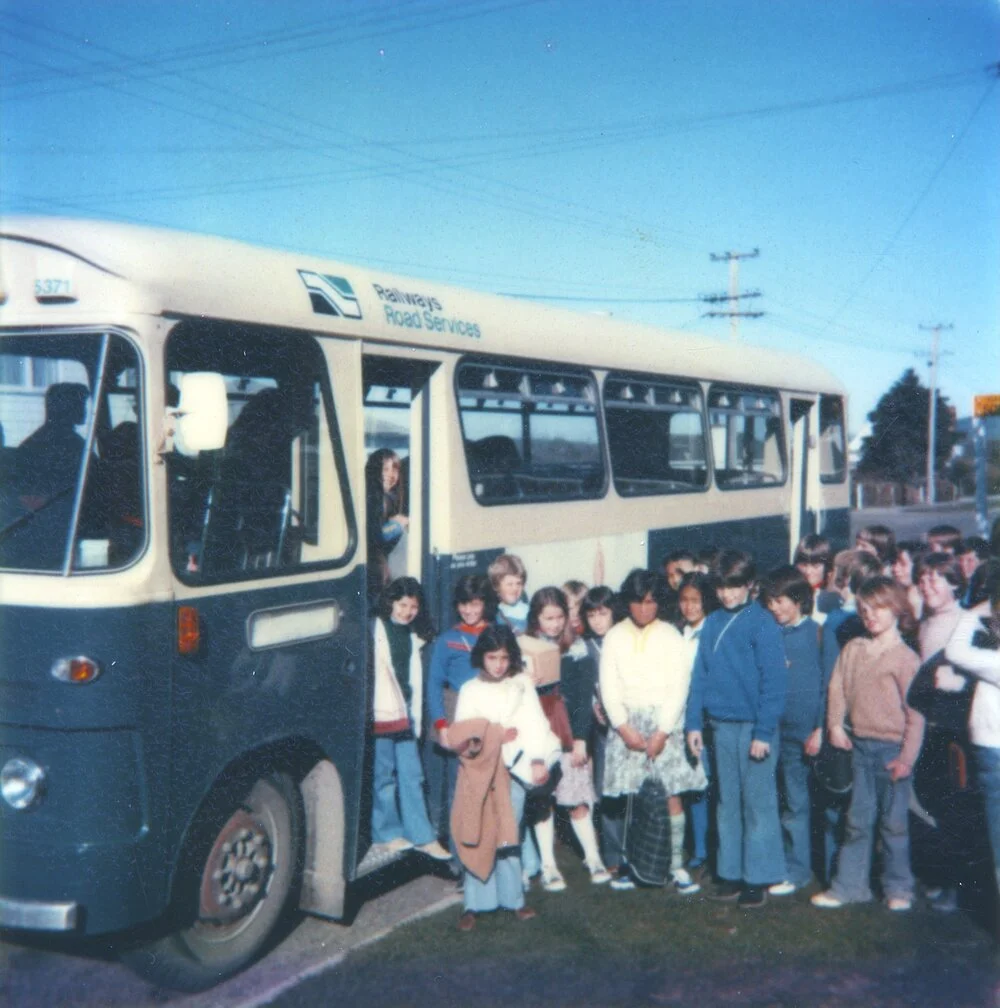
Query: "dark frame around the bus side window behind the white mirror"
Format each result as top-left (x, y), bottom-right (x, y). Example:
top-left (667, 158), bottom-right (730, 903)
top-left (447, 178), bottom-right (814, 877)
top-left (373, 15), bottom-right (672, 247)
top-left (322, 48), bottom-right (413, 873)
top-left (162, 318), bottom-right (361, 589)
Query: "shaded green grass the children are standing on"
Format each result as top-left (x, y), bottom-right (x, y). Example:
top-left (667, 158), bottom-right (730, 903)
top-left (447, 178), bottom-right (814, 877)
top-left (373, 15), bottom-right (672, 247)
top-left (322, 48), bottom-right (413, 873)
top-left (275, 848), bottom-right (1000, 1008)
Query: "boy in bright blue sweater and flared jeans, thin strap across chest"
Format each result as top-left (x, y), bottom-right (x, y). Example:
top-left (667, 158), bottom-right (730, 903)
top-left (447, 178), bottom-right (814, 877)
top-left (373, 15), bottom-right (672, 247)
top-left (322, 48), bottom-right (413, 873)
top-left (684, 549), bottom-right (788, 907)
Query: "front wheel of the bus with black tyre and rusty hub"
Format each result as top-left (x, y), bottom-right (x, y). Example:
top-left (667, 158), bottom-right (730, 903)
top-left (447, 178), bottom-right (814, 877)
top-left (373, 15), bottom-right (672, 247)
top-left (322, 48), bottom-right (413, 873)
top-left (121, 773), bottom-right (303, 992)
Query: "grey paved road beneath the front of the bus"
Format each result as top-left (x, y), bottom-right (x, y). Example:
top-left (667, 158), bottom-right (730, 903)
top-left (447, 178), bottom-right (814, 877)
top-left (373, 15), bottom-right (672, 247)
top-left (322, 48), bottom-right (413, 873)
top-left (0, 864), bottom-right (460, 1008)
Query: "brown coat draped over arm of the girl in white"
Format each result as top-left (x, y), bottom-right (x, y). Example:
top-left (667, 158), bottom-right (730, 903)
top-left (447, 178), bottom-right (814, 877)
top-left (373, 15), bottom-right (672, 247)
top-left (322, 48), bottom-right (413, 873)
top-left (448, 718), bottom-right (520, 882)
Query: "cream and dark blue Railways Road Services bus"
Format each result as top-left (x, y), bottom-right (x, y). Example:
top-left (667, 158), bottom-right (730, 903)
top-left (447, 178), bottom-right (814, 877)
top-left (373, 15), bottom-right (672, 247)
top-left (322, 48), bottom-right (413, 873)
top-left (0, 218), bottom-right (848, 989)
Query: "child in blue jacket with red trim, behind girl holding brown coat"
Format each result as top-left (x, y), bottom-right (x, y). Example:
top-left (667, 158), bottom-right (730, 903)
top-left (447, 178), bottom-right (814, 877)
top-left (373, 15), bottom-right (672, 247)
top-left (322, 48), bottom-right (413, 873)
top-left (423, 574), bottom-right (496, 850)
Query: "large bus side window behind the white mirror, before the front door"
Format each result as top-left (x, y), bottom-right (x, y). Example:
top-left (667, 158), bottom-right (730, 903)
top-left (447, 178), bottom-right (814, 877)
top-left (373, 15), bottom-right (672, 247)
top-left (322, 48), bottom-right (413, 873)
top-left (167, 326), bottom-right (352, 582)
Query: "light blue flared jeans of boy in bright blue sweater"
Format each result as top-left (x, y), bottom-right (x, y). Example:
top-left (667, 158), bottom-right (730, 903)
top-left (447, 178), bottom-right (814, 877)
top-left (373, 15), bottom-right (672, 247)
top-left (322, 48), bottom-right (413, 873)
top-left (712, 721), bottom-right (786, 886)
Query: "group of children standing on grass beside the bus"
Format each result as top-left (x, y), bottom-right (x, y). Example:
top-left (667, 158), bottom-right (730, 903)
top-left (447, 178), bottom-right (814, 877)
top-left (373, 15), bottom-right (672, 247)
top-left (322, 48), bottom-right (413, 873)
top-left (362, 526), bottom-right (1000, 930)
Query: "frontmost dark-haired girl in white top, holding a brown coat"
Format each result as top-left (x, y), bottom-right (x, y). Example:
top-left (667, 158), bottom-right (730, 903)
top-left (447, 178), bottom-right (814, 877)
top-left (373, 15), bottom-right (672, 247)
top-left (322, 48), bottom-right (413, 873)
top-left (452, 625), bottom-right (560, 931)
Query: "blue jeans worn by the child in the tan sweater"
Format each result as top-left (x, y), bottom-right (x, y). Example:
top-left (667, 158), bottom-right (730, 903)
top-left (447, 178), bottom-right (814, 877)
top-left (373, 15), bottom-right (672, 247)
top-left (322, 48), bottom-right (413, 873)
top-left (831, 737), bottom-right (913, 903)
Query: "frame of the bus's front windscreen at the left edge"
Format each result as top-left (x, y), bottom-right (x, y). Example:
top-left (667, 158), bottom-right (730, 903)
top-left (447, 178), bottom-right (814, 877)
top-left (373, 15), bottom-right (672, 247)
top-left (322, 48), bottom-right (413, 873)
top-left (0, 323), bottom-right (148, 578)
